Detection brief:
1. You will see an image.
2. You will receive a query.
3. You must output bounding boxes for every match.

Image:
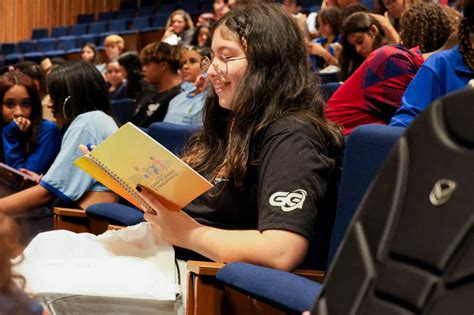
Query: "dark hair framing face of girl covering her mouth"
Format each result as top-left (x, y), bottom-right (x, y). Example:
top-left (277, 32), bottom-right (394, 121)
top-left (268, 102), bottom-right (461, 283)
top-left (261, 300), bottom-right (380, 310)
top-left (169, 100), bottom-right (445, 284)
top-left (0, 70), bottom-right (43, 160)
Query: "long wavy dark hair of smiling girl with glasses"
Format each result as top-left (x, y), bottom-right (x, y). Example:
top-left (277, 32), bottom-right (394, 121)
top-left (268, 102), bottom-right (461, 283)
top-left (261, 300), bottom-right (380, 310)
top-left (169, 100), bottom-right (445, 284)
top-left (184, 3), bottom-right (342, 188)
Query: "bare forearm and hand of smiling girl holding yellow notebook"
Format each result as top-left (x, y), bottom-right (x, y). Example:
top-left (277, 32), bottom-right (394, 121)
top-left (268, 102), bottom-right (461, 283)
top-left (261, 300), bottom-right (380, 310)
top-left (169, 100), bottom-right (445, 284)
top-left (141, 187), bottom-right (308, 271)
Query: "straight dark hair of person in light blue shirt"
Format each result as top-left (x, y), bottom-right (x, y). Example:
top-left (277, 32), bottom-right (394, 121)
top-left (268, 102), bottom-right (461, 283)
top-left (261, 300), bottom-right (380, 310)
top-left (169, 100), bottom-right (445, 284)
top-left (46, 60), bottom-right (110, 131)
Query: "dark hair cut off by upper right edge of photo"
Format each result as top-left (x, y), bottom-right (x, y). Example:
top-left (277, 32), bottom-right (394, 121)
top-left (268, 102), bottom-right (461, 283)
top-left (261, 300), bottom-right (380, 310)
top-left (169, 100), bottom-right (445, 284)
top-left (458, 0), bottom-right (474, 71)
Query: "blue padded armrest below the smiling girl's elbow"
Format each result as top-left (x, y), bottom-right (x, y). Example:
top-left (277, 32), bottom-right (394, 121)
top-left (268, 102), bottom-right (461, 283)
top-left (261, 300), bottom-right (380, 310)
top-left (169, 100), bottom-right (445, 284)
top-left (217, 262), bottom-right (321, 314)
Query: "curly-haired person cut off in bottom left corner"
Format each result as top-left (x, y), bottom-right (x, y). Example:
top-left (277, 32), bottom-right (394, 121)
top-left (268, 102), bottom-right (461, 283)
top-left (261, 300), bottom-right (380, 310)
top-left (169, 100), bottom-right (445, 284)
top-left (0, 213), bottom-right (48, 315)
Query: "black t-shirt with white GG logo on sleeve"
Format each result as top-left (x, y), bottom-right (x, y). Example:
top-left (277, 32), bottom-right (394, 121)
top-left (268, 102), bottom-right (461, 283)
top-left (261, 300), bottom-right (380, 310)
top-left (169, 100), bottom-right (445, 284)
top-left (177, 117), bottom-right (339, 269)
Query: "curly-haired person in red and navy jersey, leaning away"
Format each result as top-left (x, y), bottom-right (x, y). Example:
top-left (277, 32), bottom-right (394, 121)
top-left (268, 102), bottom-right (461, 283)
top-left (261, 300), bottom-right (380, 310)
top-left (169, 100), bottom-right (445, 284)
top-left (326, 3), bottom-right (451, 135)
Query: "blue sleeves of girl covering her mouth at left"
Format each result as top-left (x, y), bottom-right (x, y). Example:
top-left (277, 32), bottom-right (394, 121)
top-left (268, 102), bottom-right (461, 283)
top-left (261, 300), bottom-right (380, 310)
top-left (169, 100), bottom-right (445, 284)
top-left (3, 122), bottom-right (61, 174)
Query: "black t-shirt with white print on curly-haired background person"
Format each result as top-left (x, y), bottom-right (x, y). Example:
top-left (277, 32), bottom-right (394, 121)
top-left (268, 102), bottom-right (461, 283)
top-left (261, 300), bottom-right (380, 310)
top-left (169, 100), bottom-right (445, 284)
top-left (131, 85), bottom-right (182, 128)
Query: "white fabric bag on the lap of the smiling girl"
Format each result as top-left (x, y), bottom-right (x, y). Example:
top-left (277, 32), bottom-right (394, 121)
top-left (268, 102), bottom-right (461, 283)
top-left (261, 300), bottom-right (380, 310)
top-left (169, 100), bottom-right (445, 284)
top-left (14, 223), bottom-right (179, 301)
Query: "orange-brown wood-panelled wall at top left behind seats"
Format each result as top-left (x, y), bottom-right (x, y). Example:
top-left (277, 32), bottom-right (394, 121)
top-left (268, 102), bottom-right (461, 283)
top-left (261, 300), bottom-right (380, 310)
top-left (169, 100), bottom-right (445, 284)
top-left (0, 0), bottom-right (120, 43)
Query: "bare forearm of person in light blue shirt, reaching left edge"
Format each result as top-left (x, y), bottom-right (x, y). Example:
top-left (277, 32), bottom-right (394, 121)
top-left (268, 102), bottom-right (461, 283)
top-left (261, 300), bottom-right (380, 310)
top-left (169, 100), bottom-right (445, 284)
top-left (0, 185), bottom-right (54, 215)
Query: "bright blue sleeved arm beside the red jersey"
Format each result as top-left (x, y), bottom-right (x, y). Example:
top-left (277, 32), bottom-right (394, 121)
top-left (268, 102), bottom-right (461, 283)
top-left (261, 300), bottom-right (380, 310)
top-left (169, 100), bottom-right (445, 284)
top-left (390, 66), bottom-right (442, 127)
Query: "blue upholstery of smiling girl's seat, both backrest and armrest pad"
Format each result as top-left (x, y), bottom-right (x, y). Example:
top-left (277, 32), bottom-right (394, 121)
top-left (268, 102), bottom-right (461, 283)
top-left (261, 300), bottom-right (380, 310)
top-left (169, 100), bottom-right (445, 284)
top-left (217, 125), bottom-right (404, 314)
